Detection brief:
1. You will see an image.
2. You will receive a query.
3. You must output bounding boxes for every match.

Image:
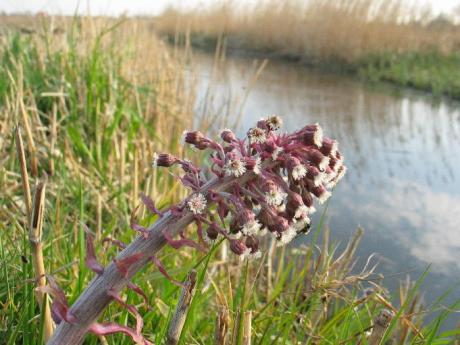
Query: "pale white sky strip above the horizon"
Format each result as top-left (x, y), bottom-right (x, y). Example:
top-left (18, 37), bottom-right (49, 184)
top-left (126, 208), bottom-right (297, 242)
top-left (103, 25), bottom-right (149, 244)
top-left (0, 0), bottom-right (460, 16)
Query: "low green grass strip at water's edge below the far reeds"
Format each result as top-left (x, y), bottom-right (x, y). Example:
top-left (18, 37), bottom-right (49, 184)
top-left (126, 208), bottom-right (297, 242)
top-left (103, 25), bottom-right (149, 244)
top-left (164, 33), bottom-right (460, 99)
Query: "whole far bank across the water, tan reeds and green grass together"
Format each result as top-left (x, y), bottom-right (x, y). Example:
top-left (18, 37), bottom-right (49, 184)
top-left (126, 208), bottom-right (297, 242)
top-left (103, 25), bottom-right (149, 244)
top-left (155, 0), bottom-right (460, 98)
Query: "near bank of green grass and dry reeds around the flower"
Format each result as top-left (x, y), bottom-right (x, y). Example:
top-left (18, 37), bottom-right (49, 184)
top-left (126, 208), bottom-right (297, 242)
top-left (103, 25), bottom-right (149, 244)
top-left (0, 14), bottom-right (459, 345)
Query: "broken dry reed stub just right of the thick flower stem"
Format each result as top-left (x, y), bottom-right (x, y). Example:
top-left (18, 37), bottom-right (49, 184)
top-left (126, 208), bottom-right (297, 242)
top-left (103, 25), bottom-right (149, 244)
top-left (166, 270), bottom-right (196, 345)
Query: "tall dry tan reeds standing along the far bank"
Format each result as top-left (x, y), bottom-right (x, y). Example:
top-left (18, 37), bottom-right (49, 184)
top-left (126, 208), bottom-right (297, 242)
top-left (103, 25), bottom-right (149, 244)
top-left (156, 0), bottom-right (460, 61)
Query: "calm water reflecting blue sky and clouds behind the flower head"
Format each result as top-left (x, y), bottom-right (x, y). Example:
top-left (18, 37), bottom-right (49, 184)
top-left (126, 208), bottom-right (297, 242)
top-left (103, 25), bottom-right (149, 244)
top-left (194, 52), bottom-right (460, 327)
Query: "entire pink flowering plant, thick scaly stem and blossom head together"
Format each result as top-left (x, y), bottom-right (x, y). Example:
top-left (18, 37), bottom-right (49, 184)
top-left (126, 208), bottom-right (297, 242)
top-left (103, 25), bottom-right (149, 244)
top-left (48, 116), bottom-right (346, 345)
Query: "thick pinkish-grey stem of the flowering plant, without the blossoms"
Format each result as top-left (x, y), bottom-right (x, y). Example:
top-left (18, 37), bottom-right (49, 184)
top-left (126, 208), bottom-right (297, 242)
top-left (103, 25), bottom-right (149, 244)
top-left (47, 173), bottom-right (254, 345)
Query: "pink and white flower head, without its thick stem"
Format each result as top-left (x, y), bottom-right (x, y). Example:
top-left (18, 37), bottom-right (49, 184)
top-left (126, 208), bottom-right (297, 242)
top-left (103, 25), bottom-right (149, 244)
top-left (153, 116), bottom-right (346, 258)
